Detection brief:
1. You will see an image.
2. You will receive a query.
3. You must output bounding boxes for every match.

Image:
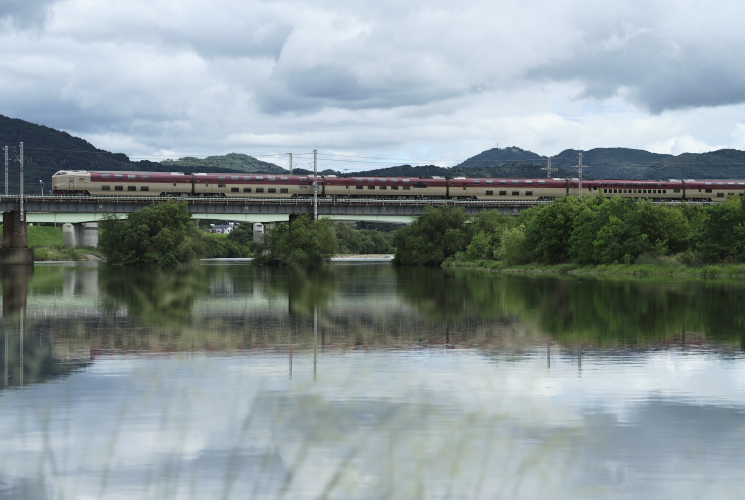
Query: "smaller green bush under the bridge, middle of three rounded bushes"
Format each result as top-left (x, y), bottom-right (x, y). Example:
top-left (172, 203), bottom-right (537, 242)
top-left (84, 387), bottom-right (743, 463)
top-left (254, 215), bottom-right (339, 267)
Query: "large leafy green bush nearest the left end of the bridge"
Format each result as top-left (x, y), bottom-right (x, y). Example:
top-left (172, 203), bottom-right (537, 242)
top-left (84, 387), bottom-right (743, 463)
top-left (99, 200), bottom-right (204, 266)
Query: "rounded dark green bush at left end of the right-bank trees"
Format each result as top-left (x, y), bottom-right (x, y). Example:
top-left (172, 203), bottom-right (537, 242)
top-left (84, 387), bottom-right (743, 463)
top-left (393, 205), bottom-right (471, 266)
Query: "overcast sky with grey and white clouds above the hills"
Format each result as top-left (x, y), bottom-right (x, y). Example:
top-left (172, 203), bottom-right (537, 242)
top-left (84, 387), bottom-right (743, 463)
top-left (0, 0), bottom-right (745, 170)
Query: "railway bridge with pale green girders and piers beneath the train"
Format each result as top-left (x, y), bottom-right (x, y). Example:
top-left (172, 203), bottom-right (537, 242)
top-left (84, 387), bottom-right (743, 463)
top-left (0, 194), bottom-right (536, 264)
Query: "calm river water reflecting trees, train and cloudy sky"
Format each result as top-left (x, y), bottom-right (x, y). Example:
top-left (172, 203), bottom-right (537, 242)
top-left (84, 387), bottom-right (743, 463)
top-left (0, 262), bottom-right (745, 500)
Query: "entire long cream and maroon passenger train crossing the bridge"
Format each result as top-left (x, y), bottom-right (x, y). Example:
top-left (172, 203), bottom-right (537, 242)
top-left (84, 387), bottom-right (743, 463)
top-left (52, 170), bottom-right (745, 201)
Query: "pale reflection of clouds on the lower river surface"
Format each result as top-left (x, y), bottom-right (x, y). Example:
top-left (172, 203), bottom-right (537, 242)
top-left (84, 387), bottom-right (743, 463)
top-left (0, 349), bottom-right (745, 499)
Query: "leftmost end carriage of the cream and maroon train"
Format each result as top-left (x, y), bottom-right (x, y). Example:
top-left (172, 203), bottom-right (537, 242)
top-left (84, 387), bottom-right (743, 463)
top-left (52, 170), bottom-right (192, 196)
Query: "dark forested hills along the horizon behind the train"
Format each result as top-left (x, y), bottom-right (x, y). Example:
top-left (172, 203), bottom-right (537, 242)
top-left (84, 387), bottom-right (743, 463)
top-left (0, 115), bottom-right (745, 193)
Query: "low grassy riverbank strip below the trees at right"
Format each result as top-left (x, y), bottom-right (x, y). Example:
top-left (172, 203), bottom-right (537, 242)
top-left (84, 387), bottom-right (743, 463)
top-left (442, 260), bottom-right (745, 279)
